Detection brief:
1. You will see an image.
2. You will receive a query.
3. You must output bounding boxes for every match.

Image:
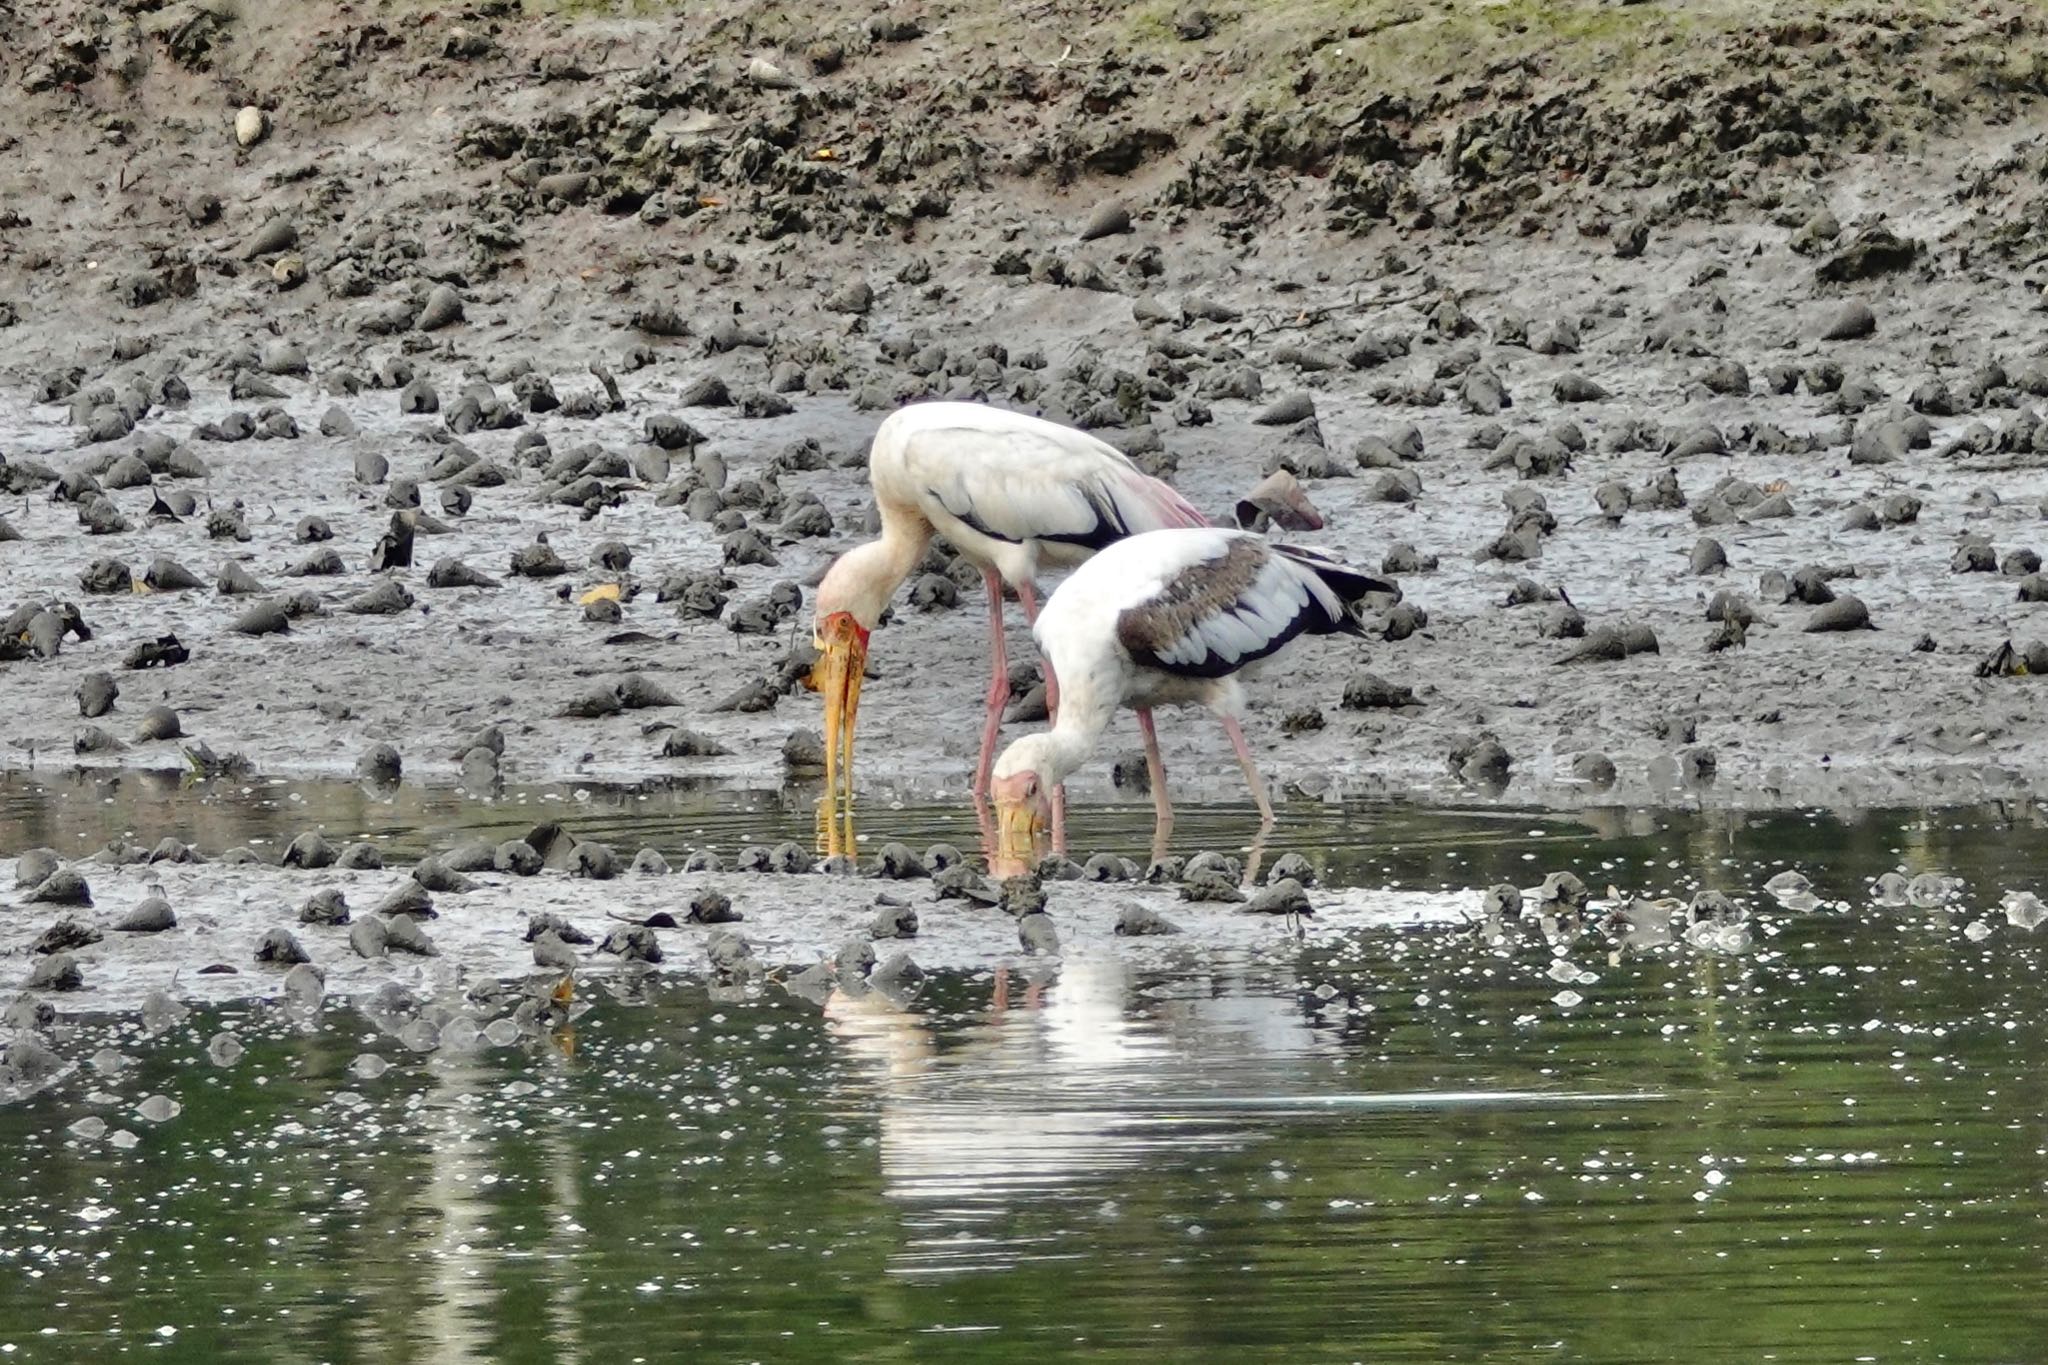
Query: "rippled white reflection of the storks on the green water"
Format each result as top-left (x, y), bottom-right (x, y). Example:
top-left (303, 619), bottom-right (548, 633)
top-left (825, 956), bottom-right (1337, 1273)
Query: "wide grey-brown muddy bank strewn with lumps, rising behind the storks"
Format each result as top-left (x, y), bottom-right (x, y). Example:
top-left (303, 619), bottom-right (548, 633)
top-left (0, 4), bottom-right (2048, 808)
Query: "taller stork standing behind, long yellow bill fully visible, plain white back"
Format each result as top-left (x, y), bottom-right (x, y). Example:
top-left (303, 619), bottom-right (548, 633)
top-left (811, 394), bottom-right (1208, 847)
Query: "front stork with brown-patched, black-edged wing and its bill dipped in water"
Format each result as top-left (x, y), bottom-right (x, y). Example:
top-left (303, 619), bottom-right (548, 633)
top-left (993, 528), bottom-right (1401, 876)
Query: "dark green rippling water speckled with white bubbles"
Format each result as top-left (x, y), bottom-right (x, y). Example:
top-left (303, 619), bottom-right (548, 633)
top-left (0, 784), bottom-right (2048, 1363)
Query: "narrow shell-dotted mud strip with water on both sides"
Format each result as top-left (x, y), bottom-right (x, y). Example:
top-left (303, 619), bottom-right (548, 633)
top-left (0, 864), bottom-right (1477, 1011)
